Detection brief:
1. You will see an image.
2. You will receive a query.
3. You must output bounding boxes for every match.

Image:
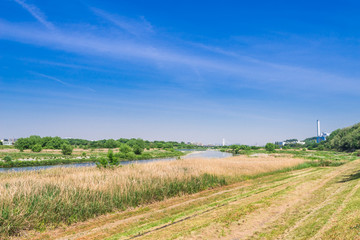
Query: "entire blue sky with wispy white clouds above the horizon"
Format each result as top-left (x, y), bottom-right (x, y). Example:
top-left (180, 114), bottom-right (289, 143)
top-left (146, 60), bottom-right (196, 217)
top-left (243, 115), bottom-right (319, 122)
top-left (0, 0), bottom-right (360, 144)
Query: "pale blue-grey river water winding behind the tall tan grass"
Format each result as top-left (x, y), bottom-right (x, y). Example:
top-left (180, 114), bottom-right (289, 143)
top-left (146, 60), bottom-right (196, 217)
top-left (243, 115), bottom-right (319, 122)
top-left (0, 150), bottom-right (232, 173)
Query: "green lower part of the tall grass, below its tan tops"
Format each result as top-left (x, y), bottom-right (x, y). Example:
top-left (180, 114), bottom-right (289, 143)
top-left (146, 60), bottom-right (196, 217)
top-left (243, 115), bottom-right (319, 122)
top-left (0, 174), bottom-right (226, 237)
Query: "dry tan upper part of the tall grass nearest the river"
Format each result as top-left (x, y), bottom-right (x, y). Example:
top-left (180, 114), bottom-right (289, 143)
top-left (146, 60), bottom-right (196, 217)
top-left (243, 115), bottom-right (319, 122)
top-left (0, 156), bottom-right (304, 195)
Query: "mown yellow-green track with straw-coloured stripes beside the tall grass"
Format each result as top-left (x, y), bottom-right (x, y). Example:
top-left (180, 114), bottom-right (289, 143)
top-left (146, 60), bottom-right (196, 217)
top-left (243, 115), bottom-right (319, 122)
top-left (15, 160), bottom-right (360, 239)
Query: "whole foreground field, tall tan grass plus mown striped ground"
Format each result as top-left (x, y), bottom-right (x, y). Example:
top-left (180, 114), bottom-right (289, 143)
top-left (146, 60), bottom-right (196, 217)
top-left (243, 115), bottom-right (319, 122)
top-left (0, 152), bottom-right (360, 239)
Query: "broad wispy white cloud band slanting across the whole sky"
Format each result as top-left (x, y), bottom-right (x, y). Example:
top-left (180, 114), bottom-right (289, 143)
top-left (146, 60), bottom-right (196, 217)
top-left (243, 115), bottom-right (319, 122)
top-left (0, 21), bottom-right (360, 94)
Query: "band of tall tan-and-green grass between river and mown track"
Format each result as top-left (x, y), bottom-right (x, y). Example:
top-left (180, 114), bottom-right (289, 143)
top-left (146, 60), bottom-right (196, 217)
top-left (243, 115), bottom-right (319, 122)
top-left (0, 151), bottom-right (352, 237)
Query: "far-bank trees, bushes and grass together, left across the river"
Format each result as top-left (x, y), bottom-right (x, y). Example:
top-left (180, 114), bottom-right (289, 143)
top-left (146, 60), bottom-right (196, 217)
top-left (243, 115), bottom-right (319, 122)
top-left (0, 136), bottom-right (191, 168)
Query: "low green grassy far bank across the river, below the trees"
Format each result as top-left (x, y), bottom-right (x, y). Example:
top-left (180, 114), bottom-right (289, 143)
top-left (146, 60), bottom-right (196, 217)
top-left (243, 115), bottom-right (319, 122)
top-left (0, 150), bottom-right (184, 168)
